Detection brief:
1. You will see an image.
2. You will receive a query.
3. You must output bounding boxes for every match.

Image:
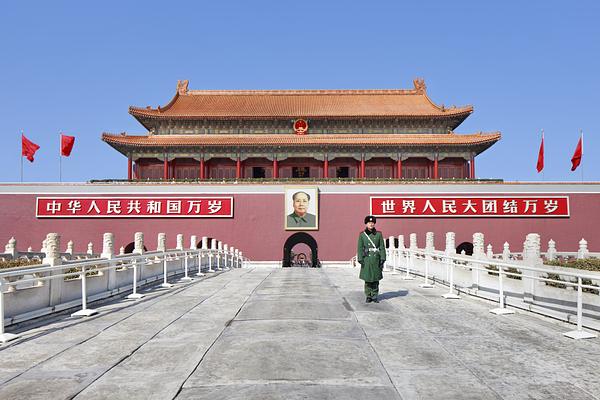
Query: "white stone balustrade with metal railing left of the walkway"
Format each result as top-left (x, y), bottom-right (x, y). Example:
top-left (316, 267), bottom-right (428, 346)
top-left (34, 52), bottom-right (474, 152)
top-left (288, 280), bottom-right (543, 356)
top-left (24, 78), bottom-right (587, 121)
top-left (0, 232), bottom-right (249, 342)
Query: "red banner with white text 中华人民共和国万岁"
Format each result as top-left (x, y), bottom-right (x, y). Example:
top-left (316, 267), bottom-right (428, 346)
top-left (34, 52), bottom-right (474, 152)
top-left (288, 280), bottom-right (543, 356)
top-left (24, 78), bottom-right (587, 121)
top-left (36, 196), bottom-right (233, 218)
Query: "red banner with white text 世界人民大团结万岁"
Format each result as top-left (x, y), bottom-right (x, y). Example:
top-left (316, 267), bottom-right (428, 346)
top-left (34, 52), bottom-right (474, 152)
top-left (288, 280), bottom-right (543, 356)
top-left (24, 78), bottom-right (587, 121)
top-left (371, 196), bottom-right (569, 217)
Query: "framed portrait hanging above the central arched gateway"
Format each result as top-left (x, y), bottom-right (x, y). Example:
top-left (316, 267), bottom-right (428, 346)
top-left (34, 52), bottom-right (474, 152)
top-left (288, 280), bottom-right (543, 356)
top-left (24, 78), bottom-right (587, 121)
top-left (283, 186), bottom-right (319, 231)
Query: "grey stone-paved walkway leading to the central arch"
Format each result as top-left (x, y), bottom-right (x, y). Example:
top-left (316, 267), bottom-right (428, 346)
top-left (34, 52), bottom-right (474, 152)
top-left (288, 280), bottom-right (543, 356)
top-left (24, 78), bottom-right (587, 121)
top-left (0, 268), bottom-right (600, 400)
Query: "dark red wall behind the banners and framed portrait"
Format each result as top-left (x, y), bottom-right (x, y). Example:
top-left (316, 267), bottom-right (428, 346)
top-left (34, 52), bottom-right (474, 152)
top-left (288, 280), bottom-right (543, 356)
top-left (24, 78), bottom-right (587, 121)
top-left (0, 185), bottom-right (600, 261)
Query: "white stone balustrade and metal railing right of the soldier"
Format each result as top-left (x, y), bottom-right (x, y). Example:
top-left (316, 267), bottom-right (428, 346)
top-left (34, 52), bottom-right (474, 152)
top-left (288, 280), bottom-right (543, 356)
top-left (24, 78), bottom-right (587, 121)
top-left (386, 232), bottom-right (600, 339)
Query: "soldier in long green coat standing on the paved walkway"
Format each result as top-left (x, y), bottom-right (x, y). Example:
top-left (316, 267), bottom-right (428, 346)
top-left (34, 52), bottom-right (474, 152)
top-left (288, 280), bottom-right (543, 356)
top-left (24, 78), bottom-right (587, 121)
top-left (357, 215), bottom-right (385, 303)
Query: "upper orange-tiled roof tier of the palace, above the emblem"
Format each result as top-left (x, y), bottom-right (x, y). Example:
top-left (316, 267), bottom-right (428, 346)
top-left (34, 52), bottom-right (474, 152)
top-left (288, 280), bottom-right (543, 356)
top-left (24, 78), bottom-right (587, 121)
top-left (129, 78), bottom-right (473, 121)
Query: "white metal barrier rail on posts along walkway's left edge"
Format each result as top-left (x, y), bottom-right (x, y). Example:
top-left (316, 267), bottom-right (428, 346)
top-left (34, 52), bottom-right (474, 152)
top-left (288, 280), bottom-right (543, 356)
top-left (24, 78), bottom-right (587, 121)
top-left (0, 249), bottom-right (248, 343)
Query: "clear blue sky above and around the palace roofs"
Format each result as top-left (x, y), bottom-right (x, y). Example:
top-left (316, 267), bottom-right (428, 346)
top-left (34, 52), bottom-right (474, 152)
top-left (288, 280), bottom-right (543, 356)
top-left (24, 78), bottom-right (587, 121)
top-left (0, 0), bottom-right (600, 181)
